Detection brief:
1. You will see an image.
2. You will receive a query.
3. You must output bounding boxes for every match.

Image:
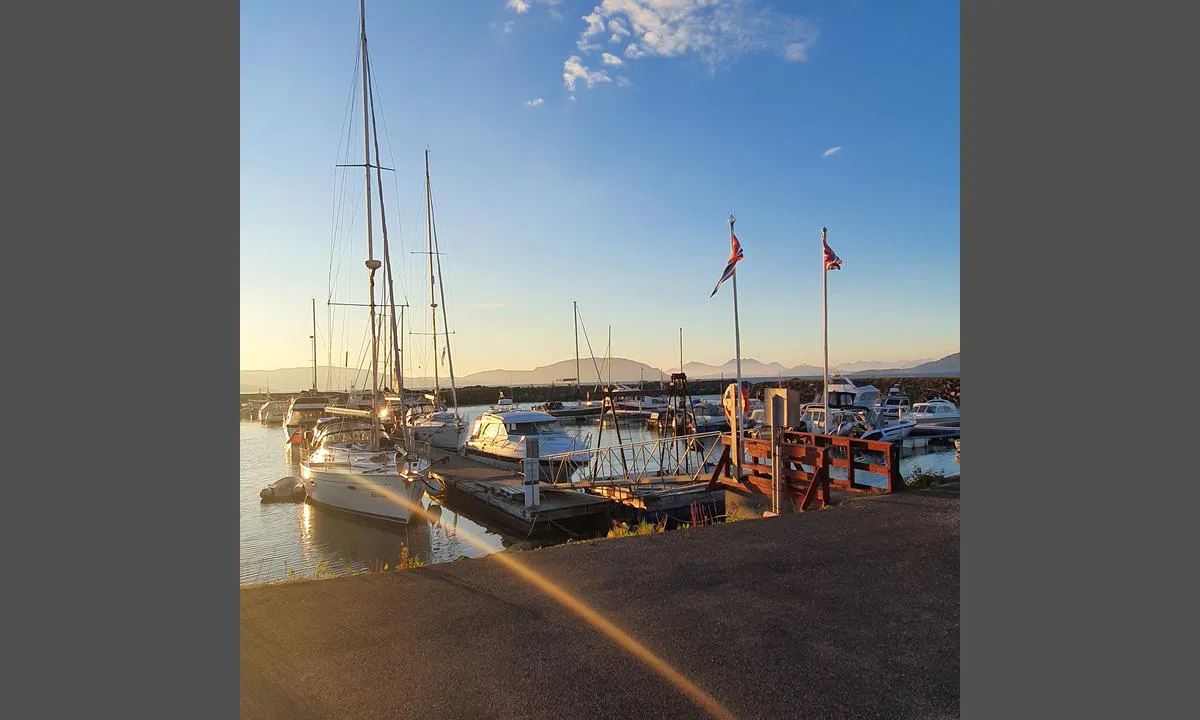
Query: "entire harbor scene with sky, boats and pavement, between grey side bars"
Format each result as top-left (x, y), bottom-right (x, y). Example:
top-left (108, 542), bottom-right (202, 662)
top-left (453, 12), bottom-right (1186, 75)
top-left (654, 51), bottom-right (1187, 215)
top-left (239, 0), bottom-right (962, 720)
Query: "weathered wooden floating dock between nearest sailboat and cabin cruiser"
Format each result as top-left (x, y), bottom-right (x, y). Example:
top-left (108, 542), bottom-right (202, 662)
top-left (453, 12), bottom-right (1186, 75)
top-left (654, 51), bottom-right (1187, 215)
top-left (430, 449), bottom-right (613, 536)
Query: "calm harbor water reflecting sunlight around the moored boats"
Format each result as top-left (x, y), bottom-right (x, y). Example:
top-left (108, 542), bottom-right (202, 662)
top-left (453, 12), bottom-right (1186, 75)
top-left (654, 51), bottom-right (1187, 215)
top-left (240, 396), bottom-right (959, 584)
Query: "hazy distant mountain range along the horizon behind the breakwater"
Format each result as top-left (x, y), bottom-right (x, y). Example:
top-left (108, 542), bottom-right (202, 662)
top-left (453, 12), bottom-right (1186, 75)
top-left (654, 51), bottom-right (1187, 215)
top-left (240, 353), bottom-right (959, 392)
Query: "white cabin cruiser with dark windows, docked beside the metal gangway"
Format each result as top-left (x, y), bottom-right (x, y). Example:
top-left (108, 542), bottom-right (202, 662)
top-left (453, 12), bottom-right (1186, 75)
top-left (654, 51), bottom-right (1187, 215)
top-left (463, 410), bottom-right (588, 481)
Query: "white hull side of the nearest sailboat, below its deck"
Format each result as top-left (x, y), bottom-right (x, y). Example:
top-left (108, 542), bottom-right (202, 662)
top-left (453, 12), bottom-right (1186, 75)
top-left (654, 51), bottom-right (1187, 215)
top-left (300, 464), bottom-right (425, 522)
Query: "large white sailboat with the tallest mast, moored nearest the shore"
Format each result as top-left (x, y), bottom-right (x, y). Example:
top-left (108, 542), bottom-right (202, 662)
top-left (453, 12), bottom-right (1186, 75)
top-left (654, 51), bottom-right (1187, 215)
top-left (300, 0), bottom-right (431, 522)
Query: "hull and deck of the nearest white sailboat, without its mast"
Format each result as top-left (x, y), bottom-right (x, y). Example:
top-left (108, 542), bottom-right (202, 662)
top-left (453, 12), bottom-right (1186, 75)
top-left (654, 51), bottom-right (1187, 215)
top-left (300, 416), bottom-right (430, 522)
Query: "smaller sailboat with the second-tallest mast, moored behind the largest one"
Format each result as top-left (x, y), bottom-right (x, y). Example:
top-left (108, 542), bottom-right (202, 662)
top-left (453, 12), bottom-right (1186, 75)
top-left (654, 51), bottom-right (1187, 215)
top-left (408, 149), bottom-right (467, 450)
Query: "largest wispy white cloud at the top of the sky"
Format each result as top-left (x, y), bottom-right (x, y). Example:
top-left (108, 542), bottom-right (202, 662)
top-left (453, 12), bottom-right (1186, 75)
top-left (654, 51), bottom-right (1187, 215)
top-left (568, 0), bottom-right (817, 68)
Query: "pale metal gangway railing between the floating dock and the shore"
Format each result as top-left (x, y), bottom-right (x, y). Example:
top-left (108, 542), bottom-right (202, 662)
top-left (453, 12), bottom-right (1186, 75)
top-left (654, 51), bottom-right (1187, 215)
top-left (541, 432), bottom-right (721, 487)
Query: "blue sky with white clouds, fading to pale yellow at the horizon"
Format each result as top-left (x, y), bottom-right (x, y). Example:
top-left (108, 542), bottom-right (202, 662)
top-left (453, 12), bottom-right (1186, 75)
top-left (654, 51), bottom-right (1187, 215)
top-left (240, 0), bottom-right (960, 376)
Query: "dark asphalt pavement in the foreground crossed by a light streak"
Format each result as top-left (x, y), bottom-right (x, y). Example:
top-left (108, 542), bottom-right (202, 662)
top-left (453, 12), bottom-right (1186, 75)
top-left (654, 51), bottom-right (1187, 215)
top-left (240, 484), bottom-right (959, 720)
